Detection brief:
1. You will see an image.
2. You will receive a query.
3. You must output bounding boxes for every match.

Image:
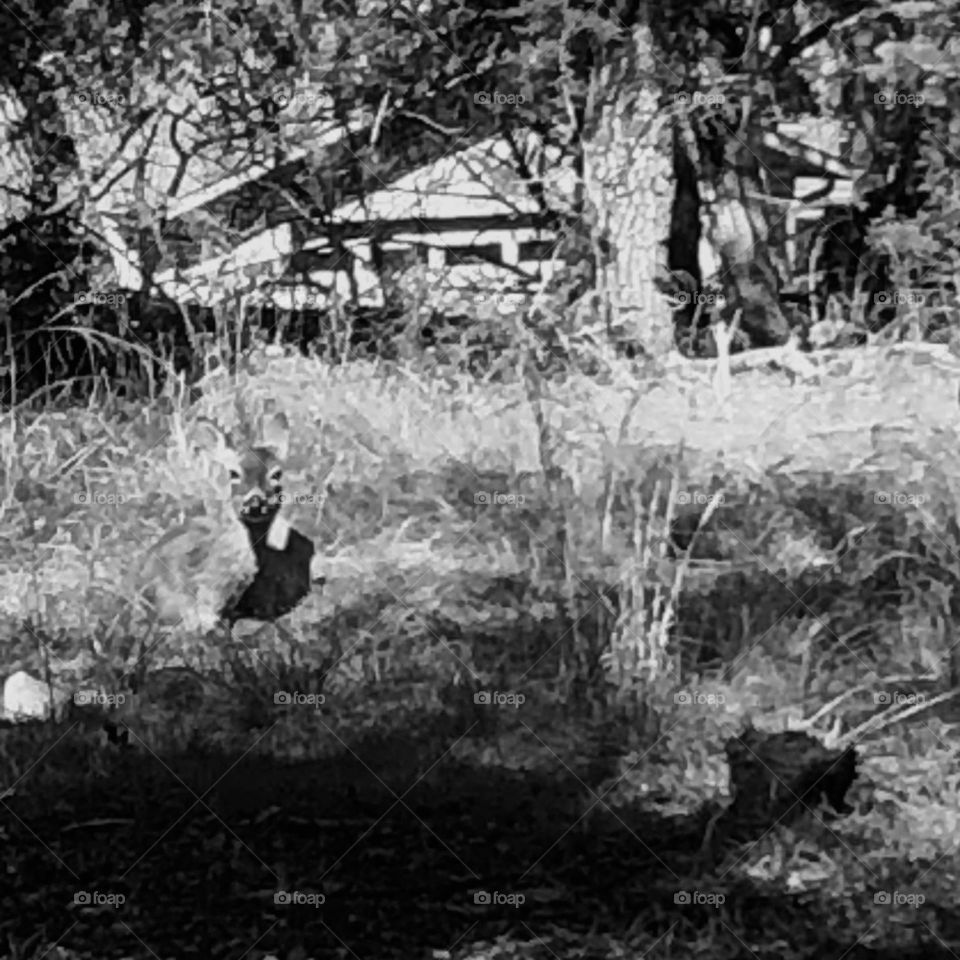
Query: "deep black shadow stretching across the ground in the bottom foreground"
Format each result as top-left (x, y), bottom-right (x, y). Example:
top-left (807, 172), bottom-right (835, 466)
top-left (0, 724), bottom-right (956, 958)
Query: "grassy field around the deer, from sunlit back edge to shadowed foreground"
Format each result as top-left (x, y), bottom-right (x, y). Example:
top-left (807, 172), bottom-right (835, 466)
top-left (0, 348), bottom-right (960, 958)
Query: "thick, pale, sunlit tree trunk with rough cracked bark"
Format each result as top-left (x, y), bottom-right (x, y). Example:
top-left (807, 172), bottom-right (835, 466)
top-left (584, 22), bottom-right (674, 356)
